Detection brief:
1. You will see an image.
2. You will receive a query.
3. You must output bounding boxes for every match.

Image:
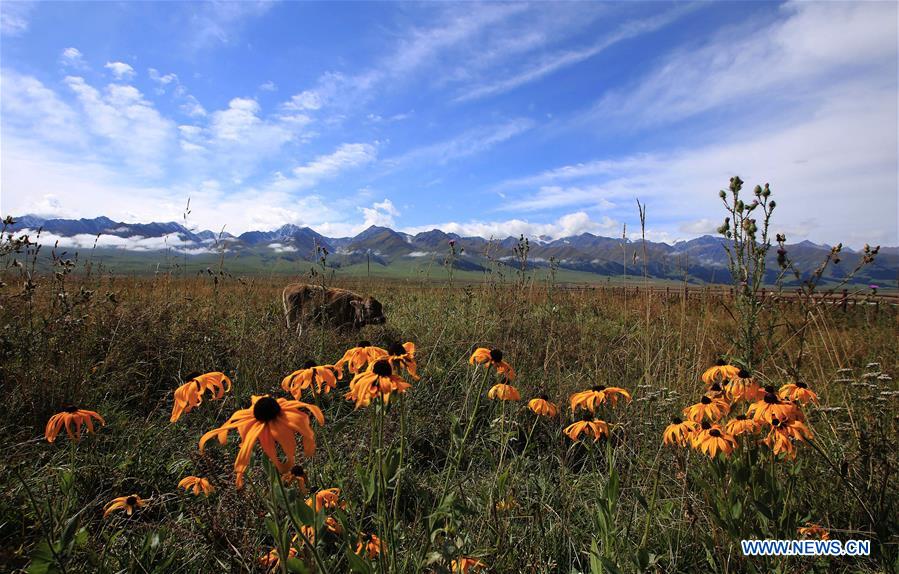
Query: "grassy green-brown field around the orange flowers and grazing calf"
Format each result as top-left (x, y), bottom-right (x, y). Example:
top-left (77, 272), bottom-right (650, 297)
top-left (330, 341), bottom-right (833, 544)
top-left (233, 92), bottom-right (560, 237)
top-left (0, 262), bottom-right (899, 572)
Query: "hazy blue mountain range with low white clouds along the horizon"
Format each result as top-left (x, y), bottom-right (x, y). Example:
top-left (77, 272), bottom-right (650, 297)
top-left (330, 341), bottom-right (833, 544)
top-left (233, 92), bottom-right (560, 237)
top-left (6, 215), bottom-right (899, 287)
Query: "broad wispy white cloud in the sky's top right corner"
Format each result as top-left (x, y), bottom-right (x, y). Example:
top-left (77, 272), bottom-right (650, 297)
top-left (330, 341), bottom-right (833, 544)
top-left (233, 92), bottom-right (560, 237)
top-left (596, 2), bottom-right (897, 125)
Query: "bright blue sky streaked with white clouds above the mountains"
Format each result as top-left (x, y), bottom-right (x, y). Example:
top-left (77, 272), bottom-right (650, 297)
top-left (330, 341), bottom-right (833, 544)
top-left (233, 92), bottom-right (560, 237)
top-left (0, 1), bottom-right (899, 245)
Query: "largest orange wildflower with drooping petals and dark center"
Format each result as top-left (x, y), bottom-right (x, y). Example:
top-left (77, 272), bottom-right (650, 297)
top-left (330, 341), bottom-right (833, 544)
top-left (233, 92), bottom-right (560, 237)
top-left (200, 395), bottom-right (325, 488)
